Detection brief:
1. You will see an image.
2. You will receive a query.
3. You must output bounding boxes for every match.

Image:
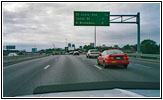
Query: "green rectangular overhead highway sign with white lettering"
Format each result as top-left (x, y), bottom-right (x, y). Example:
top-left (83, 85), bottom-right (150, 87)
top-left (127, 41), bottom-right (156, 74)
top-left (74, 11), bottom-right (110, 26)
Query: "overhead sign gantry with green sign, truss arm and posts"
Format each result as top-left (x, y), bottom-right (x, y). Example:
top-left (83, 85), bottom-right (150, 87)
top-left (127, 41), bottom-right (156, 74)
top-left (74, 11), bottom-right (140, 52)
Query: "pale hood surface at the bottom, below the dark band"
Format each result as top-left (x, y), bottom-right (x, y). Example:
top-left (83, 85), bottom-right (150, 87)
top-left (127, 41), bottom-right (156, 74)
top-left (17, 88), bottom-right (160, 98)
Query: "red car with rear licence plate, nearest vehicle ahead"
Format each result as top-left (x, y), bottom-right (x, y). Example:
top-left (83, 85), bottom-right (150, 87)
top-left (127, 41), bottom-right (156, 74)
top-left (97, 50), bottom-right (129, 68)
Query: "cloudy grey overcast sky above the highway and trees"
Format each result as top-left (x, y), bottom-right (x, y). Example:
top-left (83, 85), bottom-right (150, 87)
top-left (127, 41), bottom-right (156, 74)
top-left (2, 2), bottom-right (160, 51)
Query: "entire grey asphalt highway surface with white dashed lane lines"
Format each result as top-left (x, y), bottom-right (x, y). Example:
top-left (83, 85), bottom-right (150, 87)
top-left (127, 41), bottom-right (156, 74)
top-left (3, 55), bottom-right (160, 97)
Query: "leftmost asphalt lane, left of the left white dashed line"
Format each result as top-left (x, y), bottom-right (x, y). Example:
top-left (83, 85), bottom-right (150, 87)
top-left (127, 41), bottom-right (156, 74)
top-left (3, 56), bottom-right (58, 82)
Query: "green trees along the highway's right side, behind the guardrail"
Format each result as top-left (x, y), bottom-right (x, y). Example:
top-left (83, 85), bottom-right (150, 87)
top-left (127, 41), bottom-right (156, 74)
top-left (83, 39), bottom-right (160, 54)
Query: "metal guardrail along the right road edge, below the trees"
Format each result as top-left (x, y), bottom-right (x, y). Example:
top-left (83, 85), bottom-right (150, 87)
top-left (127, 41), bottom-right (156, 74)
top-left (126, 53), bottom-right (160, 59)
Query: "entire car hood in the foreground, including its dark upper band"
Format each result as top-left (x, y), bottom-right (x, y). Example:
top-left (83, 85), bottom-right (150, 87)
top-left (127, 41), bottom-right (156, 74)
top-left (15, 81), bottom-right (160, 97)
